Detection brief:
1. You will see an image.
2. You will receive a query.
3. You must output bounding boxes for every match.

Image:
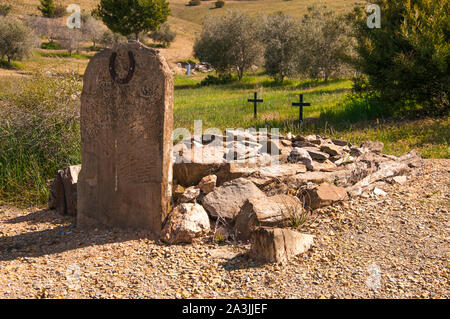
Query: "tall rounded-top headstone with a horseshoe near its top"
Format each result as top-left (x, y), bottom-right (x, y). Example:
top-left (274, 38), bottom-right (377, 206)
top-left (78, 42), bottom-right (173, 235)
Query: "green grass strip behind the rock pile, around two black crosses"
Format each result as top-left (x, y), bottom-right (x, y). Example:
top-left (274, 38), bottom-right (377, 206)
top-left (174, 74), bottom-right (450, 158)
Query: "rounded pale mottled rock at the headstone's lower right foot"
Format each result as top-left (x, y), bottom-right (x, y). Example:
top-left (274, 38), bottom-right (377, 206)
top-left (161, 203), bottom-right (211, 244)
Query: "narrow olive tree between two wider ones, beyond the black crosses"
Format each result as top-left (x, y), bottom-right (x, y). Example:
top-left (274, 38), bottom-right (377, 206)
top-left (262, 12), bottom-right (300, 82)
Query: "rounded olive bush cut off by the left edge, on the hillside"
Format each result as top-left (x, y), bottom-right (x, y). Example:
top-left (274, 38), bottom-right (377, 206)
top-left (0, 17), bottom-right (36, 63)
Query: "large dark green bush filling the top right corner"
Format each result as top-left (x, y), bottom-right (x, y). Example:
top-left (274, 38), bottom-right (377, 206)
top-left (352, 0), bottom-right (450, 113)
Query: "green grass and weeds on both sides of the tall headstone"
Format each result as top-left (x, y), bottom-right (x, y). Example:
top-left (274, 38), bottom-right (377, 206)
top-left (0, 74), bottom-right (450, 206)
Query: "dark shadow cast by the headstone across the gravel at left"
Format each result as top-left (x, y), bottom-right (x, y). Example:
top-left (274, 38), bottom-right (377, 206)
top-left (0, 210), bottom-right (156, 261)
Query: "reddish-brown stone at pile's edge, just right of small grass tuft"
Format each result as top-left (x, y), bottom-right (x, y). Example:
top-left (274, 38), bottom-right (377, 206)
top-left (303, 183), bottom-right (348, 209)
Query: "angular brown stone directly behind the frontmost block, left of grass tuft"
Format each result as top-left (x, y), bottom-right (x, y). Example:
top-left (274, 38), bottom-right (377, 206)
top-left (235, 194), bottom-right (303, 240)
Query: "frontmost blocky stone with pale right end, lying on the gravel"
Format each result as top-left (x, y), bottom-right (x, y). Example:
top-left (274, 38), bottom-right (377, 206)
top-left (250, 227), bottom-right (314, 263)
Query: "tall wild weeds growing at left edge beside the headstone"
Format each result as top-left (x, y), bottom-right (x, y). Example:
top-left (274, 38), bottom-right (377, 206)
top-left (0, 74), bottom-right (81, 205)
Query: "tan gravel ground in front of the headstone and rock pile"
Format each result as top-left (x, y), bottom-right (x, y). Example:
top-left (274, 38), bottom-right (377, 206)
top-left (0, 160), bottom-right (450, 298)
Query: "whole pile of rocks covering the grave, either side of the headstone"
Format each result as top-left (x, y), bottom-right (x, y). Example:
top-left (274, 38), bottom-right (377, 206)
top-left (51, 131), bottom-right (421, 262)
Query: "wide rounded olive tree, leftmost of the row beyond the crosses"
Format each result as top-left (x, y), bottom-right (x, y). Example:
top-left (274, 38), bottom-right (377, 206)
top-left (194, 11), bottom-right (263, 80)
